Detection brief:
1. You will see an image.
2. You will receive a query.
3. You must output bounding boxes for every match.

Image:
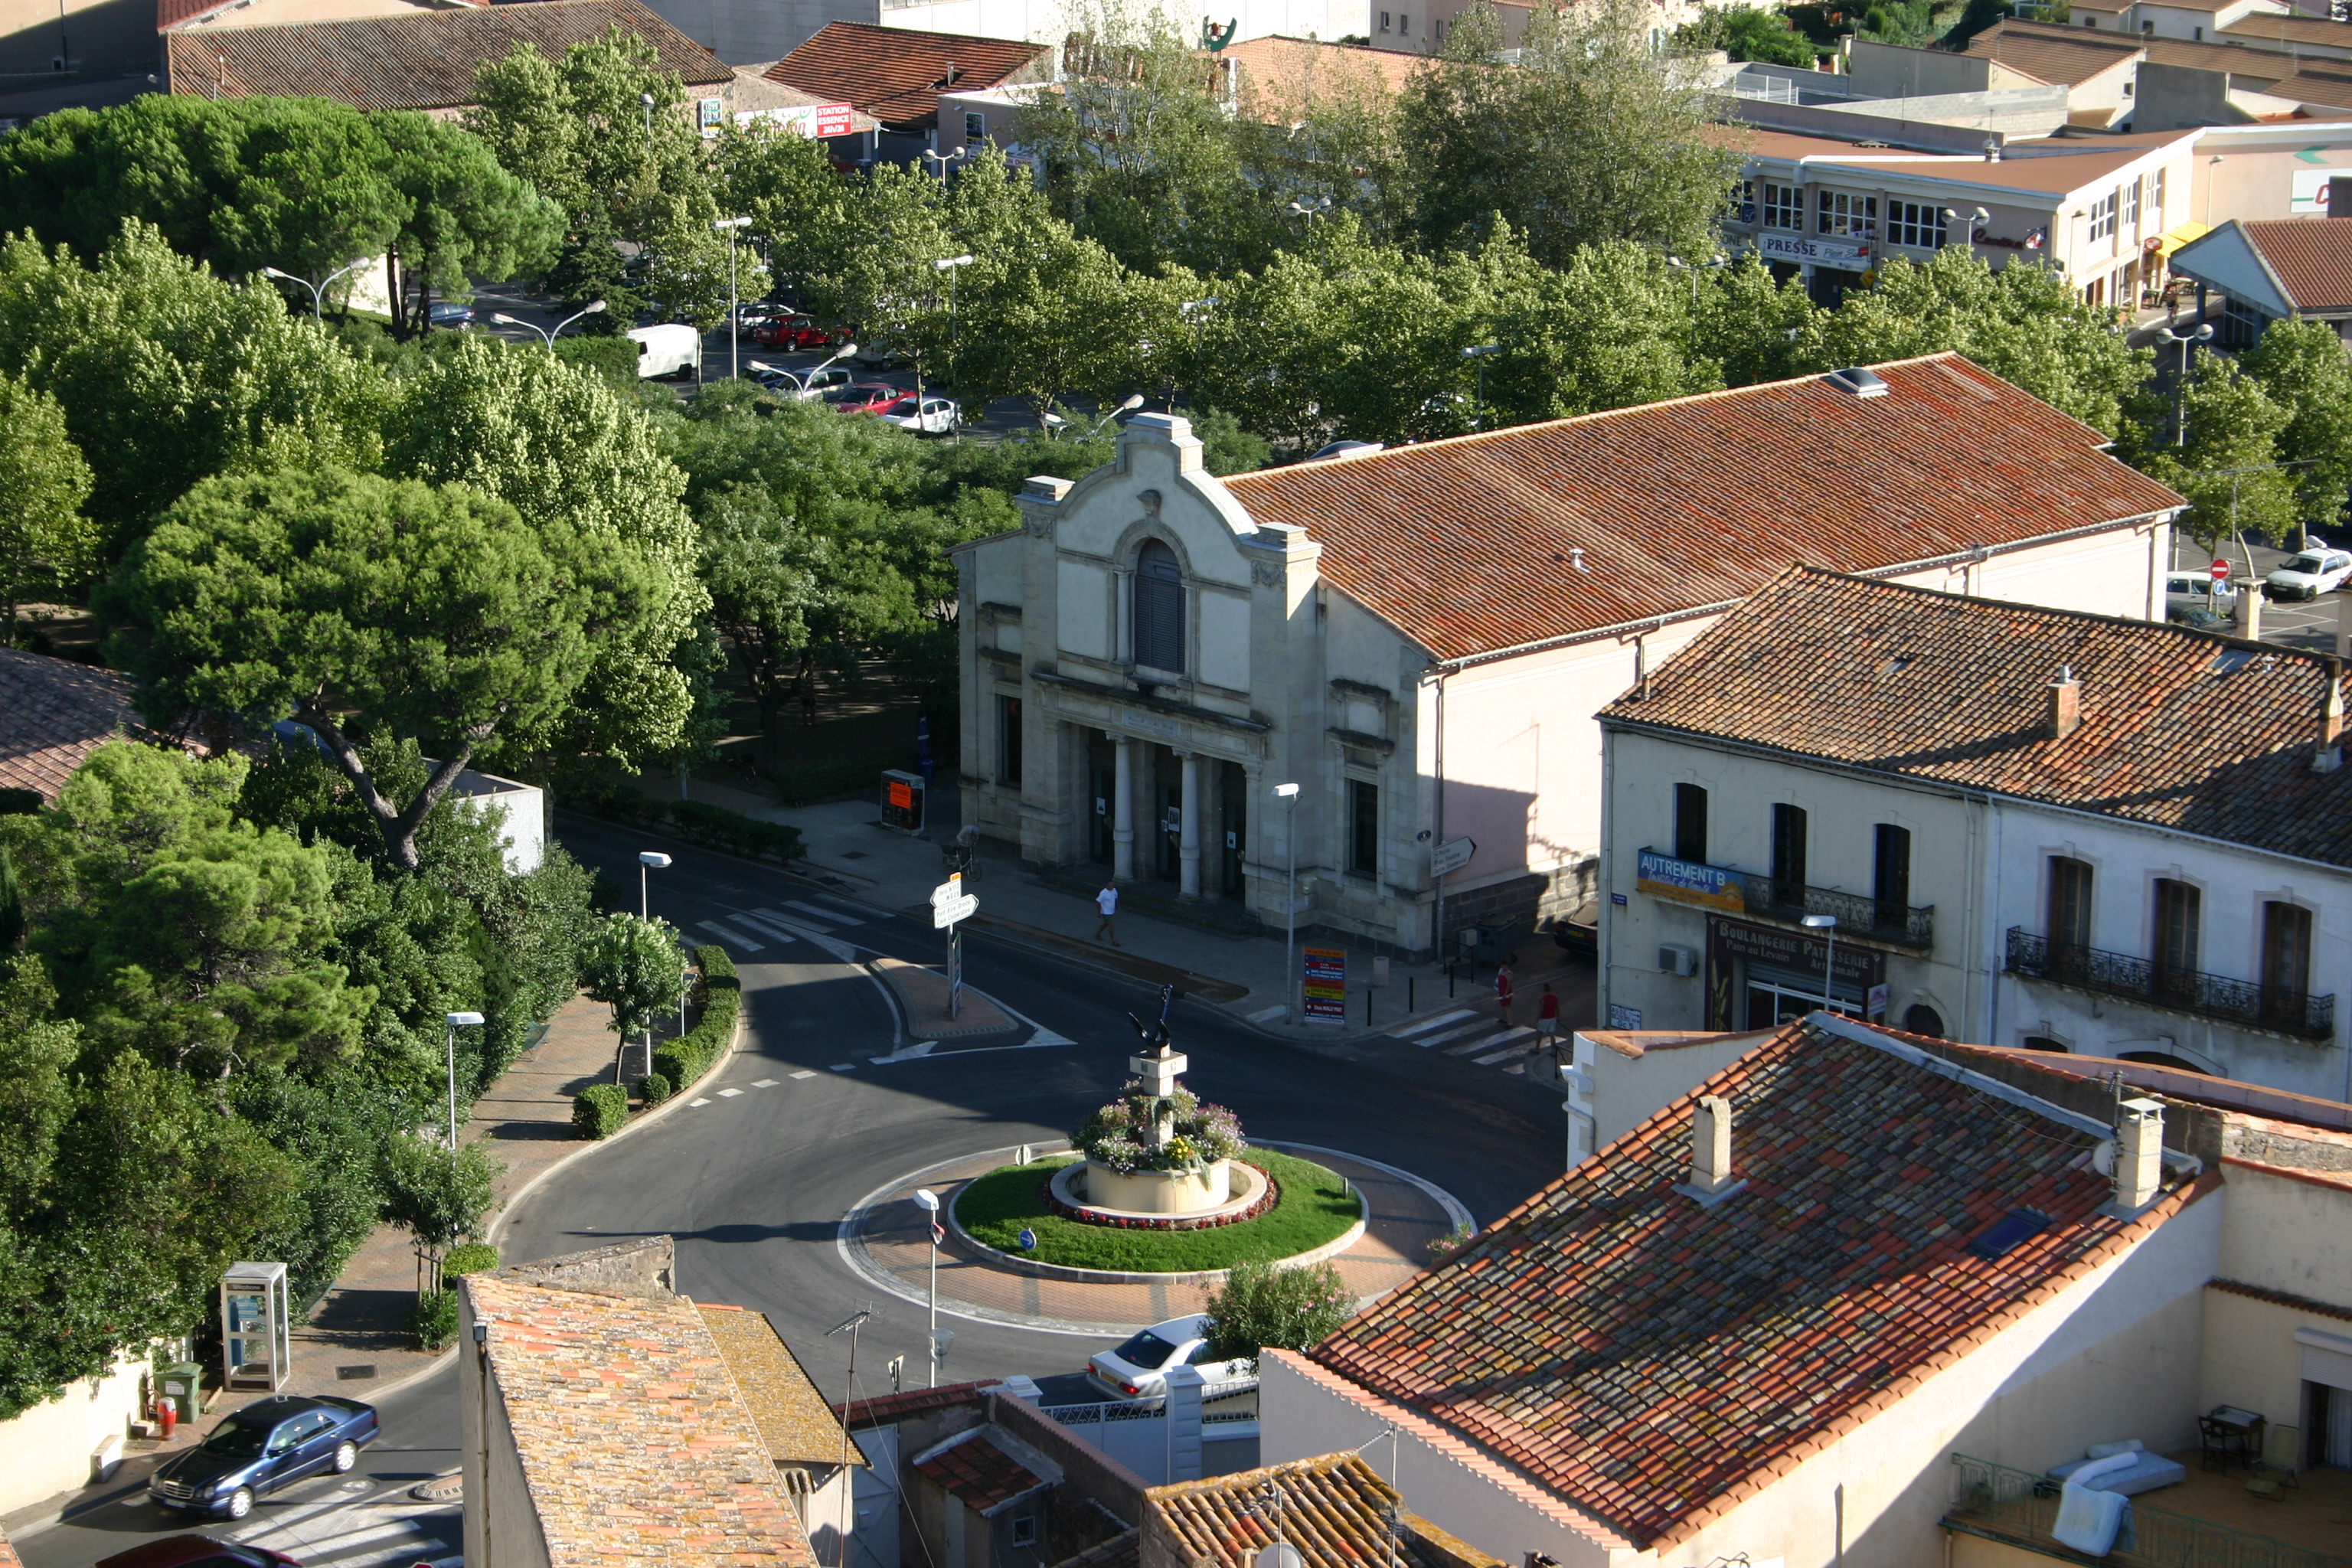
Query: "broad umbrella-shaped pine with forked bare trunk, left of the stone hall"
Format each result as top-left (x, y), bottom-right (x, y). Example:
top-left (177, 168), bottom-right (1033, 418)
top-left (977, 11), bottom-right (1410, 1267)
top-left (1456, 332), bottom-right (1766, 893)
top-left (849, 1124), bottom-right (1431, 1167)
top-left (101, 470), bottom-right (635, 870)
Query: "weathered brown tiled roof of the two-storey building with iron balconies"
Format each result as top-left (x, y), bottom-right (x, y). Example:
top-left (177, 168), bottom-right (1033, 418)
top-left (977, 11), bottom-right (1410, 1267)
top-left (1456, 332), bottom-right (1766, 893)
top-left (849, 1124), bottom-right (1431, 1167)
top-left (1602, 567), bottom-right (2352, 865)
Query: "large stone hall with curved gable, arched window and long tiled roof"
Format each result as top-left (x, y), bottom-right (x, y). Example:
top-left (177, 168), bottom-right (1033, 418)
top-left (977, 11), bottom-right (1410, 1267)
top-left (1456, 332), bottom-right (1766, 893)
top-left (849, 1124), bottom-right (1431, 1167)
top-left (955, 355), bottom-right (2180, 952)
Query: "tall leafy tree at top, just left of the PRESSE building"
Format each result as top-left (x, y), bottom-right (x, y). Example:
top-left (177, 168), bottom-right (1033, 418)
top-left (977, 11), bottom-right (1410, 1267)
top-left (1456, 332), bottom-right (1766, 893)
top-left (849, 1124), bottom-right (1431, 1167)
top-left (1400, 0), bottom-right (1738, 266)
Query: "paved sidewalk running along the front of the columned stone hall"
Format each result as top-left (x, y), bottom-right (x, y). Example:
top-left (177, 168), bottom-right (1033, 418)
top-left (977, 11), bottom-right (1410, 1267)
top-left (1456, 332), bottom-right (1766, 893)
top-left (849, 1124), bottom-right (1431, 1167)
top-left (635, 776), bottom-right (1595, 1048)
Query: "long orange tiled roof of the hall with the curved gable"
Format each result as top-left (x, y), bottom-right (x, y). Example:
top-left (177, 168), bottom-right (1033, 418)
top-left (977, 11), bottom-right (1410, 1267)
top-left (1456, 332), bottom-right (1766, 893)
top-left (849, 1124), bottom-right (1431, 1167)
top-left (1226, 355), bottom-right (2183, 658)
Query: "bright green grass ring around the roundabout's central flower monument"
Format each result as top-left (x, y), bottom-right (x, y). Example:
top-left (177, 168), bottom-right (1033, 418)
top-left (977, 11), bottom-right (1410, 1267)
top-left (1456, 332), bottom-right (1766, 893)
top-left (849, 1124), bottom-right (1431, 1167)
top-left (955, 1147), bottom-right (1364, 1274)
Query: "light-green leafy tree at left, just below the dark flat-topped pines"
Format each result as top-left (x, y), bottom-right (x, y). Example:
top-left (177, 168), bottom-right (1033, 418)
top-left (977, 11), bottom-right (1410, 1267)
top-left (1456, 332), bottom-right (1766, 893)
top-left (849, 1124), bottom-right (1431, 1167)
top-left (0, 224), bottom-right (381, 560)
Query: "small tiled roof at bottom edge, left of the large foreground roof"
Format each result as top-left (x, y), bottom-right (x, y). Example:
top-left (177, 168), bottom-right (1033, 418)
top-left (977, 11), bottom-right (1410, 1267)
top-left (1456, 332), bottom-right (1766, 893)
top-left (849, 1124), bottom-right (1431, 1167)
top-left (1143, 1453), bottom-right (1501, 1568)
